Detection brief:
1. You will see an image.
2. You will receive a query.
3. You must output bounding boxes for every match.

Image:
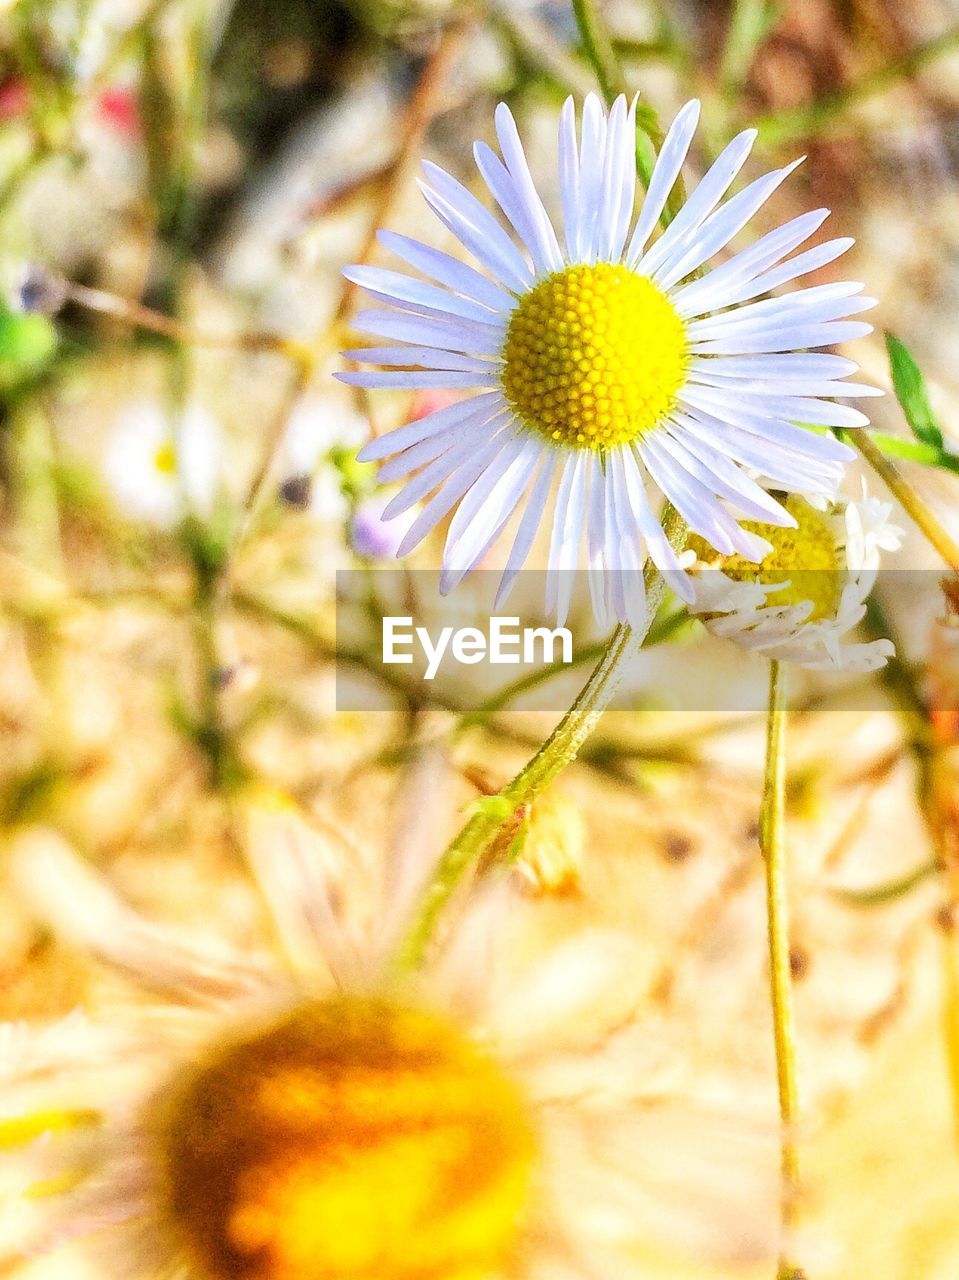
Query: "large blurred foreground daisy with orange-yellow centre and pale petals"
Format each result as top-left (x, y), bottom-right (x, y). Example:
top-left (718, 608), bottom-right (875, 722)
top-left (0, 814), bottom-right (776, 1280)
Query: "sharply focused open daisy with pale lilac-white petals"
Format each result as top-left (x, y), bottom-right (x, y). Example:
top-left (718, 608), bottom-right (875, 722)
top-left (338, 95), bottom-right (878, 622)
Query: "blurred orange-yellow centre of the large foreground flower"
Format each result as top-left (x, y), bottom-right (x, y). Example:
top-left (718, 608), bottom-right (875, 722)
top-left (153, 996), bottom-right (534, 1280)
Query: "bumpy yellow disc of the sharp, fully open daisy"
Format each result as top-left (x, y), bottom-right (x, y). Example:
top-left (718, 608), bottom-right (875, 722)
top-left (502, 262), bottom-right (688, 449)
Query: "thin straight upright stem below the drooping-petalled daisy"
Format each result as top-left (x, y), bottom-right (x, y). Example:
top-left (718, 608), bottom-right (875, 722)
top-left (759, 660), bottom-right (803, 1280)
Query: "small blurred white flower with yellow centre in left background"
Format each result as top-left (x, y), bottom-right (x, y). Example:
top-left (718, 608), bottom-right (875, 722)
top-left (104, 399), bottom-right (223, 529)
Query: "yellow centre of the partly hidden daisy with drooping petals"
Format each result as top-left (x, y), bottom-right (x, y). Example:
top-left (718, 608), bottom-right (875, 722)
top-left (689, 494), bottom-right (844, 621)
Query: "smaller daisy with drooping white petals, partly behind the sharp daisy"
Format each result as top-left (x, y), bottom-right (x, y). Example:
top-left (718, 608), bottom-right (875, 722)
top-left (691, 485), bottom-right (901, 671)
